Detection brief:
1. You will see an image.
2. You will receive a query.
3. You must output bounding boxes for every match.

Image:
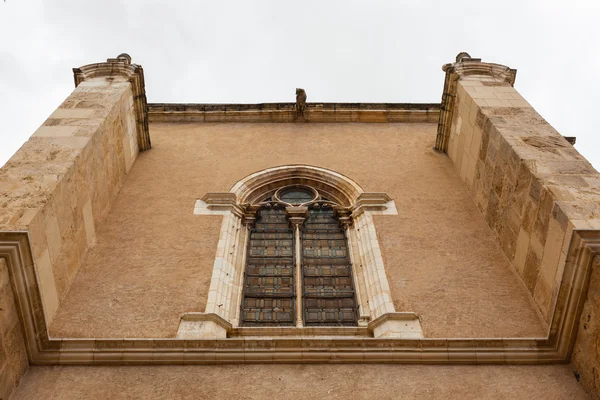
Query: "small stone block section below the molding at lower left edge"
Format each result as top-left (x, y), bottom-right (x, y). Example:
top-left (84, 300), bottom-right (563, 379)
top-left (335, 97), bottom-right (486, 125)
top-left (0, 258), bottom-right (29, 399)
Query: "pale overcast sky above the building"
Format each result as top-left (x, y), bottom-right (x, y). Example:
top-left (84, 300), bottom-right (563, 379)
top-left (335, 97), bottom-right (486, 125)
top-left (0, 0), bottom-right (600, 169)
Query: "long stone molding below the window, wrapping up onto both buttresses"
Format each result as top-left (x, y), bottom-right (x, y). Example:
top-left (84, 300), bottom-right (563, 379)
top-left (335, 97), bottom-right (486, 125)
top-left (0, 230), bottom-right (600, 365)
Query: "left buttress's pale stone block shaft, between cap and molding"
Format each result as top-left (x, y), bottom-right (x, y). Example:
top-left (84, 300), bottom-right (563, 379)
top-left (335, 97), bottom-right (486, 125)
top-left (0, 77), bottom-right (138, 324)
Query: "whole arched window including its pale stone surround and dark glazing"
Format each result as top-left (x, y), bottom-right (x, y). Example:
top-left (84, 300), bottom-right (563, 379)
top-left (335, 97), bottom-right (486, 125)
top-left (192, 165), bottom-right (422, 338)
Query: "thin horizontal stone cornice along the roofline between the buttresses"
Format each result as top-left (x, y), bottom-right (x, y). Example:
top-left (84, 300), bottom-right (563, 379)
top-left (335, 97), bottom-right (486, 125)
top-left (148, 103), bottom-right (440, 123)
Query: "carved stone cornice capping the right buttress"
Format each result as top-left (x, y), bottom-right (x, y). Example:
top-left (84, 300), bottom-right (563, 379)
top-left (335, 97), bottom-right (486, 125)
top-left (435, 52), bottom-right (517, 153)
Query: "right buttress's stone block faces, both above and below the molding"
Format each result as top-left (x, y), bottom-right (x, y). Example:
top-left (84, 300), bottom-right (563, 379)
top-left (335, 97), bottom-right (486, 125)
top-left (447, 63), bottom-right (600, 398)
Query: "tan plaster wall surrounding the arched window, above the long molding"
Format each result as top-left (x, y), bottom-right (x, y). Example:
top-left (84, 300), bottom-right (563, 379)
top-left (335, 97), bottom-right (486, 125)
top-left (50, 123), bottom-right (546, 337)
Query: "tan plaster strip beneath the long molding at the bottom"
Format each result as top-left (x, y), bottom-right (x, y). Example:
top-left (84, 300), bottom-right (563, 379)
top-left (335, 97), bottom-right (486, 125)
top-left (11, 365), bottom-right (587, 400)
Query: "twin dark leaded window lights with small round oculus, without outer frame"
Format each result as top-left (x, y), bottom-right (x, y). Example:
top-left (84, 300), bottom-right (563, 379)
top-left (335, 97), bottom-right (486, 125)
top-left (240, 185), bottom-right (358, 326)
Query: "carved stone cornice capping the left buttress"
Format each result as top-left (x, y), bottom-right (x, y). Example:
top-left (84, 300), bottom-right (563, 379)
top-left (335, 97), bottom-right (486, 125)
top-left (73, 53), bottom-right (152, 151)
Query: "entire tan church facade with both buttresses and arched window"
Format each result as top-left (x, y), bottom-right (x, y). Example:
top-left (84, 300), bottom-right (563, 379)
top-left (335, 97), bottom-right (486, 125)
top-left (0, 53), bottom-right (600, 399)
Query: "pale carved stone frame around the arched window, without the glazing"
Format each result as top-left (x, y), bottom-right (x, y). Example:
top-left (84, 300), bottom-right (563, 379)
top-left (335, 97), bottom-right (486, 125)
top-left (178, 165), bottom-right (423, 339)
